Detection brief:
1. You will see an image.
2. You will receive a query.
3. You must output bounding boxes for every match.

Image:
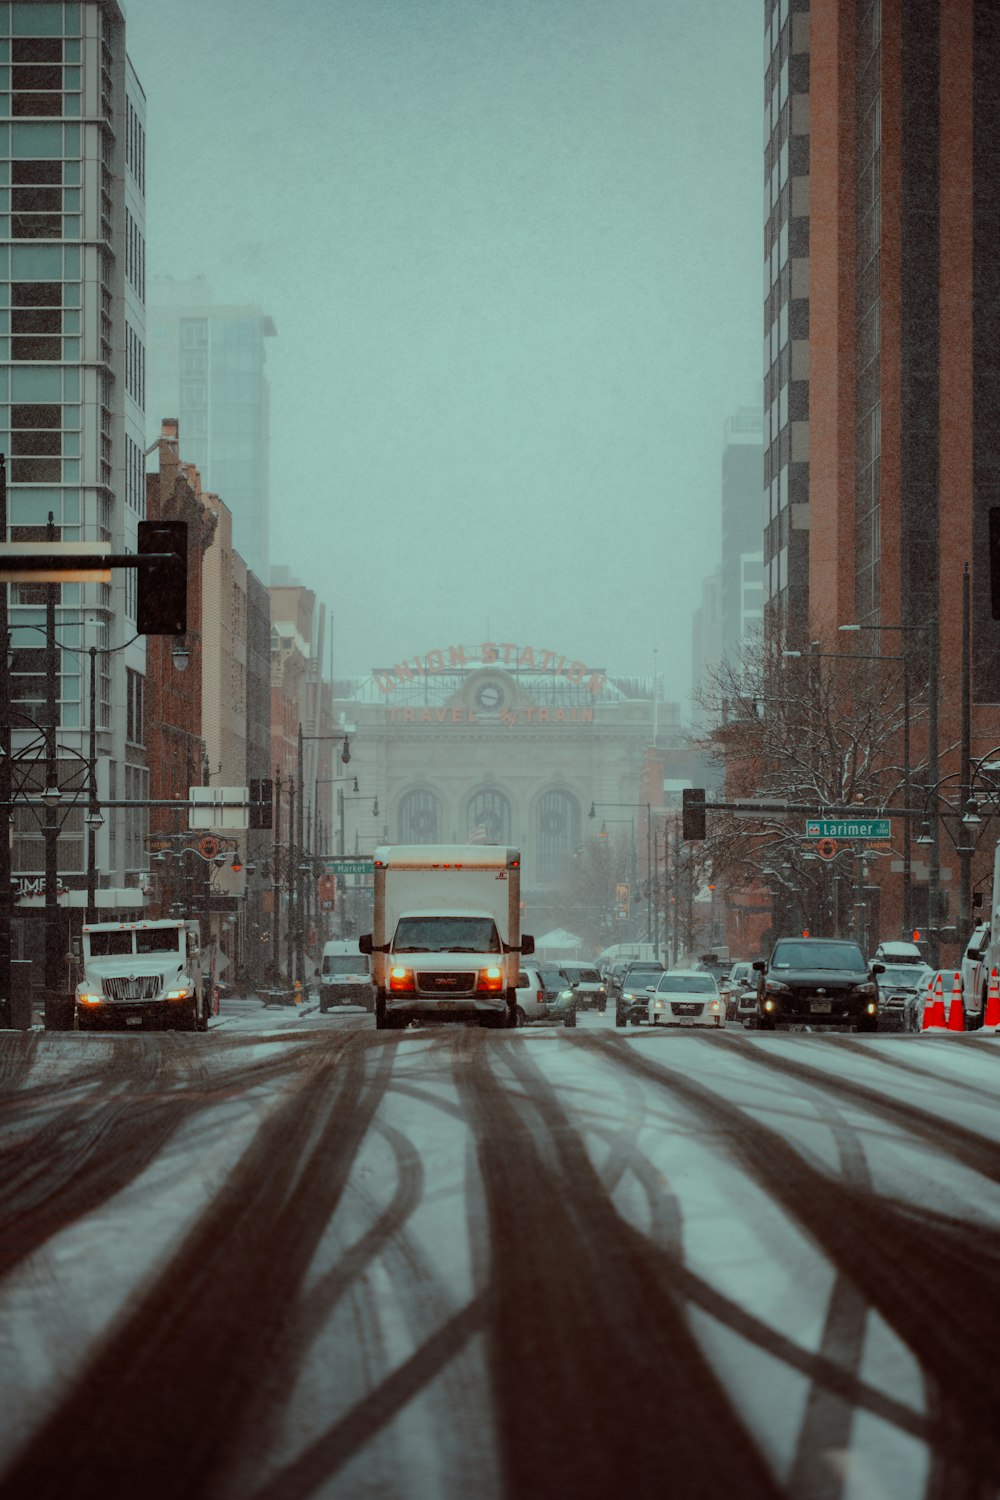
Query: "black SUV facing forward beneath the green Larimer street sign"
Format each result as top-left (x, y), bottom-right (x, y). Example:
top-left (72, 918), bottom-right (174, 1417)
top-left (754, 938), bottom-right (883, 1032)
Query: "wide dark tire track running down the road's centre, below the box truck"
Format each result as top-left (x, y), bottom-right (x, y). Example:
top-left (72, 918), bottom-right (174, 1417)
top-left (454, 1032), bottom-right (780, 1500)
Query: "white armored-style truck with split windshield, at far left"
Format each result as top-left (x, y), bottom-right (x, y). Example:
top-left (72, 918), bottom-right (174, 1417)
top-left (75, 920), bottom-right (210, 1031)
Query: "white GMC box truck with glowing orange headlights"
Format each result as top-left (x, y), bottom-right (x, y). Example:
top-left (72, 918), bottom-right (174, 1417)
top-left (358, 845), bottom-right (535, 1031)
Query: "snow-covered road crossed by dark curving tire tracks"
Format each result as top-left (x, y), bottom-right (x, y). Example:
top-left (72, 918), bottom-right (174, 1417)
top-left (0, 1002), bottom-right (1000, 1500)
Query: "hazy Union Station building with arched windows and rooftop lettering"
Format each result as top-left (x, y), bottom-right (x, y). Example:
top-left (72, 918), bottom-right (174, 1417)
top-left (331, 642), bottom-right (704, 918)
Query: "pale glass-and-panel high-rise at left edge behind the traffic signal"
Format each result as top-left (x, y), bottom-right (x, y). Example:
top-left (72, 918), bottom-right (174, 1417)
top-left (0, 0), bottom-right (148, 911)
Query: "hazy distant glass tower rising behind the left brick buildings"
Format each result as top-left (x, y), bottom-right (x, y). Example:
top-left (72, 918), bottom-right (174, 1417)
top-left (147, 276), bottom-right (276, 579)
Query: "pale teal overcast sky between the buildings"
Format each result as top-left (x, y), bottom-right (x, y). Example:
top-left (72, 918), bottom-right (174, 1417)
top-left (126, 0), bottom-right (763, 702)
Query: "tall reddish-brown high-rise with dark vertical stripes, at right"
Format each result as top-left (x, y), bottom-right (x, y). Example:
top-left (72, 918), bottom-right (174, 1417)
top-left (765, 0), bottom-right (1000, 957)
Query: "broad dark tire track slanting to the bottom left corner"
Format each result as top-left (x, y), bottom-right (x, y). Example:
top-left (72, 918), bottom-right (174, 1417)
top-left (3, 1034), bottom-right (391, 1500)
